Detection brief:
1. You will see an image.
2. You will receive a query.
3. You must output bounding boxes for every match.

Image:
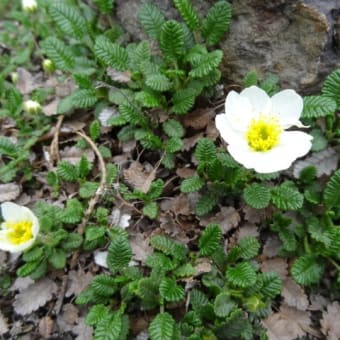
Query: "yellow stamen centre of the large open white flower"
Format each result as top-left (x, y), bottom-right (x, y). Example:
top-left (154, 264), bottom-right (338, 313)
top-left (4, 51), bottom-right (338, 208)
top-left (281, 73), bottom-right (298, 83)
top-left (246, 115), bottom-right (282, 151)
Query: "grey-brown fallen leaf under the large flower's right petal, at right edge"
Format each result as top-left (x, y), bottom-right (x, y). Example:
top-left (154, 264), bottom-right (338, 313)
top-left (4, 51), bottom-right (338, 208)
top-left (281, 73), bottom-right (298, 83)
top-left (293, 148), bottom-right (340, 178)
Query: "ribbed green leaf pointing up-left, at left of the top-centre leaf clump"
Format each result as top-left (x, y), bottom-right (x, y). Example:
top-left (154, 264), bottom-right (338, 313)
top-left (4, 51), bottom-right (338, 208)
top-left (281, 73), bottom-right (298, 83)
top-left (94, 36), bottom-right (128, 71)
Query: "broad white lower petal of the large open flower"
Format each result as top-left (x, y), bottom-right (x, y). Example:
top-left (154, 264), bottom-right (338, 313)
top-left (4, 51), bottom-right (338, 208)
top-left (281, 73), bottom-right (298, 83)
top-left (228, 131), bottom-right (312, 173)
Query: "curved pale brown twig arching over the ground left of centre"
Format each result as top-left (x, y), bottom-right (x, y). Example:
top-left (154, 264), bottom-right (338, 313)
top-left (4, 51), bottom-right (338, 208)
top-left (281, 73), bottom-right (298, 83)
top-left (76, 131), bottom-right (107, 235)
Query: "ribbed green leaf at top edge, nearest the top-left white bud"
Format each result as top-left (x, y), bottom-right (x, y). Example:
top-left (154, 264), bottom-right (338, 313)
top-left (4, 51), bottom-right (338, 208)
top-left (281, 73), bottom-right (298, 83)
top-left (49, 2), bottom-right (87, 40)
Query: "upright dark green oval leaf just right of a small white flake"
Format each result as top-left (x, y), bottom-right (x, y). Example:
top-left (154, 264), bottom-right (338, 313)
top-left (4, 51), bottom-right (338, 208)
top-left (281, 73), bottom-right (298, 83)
top-left (107, 235), bottom-right (132, 273)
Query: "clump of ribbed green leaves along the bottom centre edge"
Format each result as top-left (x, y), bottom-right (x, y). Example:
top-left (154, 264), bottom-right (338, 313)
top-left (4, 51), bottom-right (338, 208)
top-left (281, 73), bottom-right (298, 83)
top-left (76, 224), bottom-right (281, 340)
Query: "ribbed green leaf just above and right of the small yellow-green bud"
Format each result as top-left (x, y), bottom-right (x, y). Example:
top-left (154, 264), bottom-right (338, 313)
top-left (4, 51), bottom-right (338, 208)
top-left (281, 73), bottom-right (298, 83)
top-left (40, 37), bottom-right (75, 71)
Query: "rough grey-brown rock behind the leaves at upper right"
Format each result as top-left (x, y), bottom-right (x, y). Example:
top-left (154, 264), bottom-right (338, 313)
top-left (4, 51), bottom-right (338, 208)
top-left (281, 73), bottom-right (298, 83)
top-left (116, 0), bottom-right (340, 93)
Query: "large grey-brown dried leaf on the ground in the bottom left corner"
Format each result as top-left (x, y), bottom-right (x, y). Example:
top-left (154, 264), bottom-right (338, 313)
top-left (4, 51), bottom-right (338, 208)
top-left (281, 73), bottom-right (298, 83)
top-left (13, 278), bottom-right (58, 315)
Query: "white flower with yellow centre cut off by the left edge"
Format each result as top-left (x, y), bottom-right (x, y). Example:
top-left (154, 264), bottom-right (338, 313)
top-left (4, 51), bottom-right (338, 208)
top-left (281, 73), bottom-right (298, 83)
top-left (0, 202), bottom-right (39, 253)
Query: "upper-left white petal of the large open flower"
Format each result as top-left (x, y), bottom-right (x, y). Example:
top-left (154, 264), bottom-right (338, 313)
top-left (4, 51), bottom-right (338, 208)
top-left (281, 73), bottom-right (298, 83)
top-left (225, 91), bottom-right (253, 131)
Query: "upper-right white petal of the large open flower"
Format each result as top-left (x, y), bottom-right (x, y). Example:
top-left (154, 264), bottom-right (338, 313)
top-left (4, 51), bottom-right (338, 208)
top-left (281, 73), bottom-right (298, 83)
top-left (271, 90), bottom-right (303, 128)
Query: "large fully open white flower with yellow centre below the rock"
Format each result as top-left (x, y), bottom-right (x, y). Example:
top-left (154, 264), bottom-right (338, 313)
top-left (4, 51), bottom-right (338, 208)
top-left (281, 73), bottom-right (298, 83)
top-left (216, 86), bottom-right (313, 173)
